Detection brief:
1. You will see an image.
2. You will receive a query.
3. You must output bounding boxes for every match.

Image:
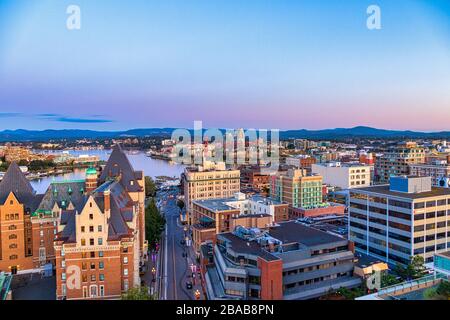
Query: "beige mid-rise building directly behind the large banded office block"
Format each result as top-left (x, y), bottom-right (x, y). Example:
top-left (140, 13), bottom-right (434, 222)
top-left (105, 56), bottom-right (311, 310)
top-left (375, 143), bottom-right (425, 184)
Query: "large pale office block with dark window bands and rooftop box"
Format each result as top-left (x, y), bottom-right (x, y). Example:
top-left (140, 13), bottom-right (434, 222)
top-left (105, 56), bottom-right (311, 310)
top-left (349, 176), bottom-right (450, 264)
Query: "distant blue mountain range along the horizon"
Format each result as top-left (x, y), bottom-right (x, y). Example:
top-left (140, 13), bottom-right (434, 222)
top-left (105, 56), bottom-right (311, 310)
top-left (0, 126), bottom-right (450, 142)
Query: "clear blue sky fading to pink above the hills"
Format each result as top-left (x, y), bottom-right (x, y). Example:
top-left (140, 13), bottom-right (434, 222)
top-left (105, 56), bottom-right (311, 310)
top-left (0, 0), bottom-right (450, 131)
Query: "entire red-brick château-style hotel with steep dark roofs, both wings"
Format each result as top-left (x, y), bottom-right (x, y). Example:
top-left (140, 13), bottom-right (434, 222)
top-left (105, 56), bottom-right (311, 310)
top-left (0, 146), bottom-right (147, 299)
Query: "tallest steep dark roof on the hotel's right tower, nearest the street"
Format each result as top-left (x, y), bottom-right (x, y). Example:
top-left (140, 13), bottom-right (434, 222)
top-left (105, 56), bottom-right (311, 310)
top-left (100, 144), bottom-right (141, 192)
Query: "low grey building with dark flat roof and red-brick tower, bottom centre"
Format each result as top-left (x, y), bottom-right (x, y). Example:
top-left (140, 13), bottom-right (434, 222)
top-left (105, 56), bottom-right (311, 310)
top-left (200, 221), bottom-right (361, 300)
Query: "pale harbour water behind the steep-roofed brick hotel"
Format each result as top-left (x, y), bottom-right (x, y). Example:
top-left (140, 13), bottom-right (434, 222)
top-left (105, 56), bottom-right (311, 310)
top-left (31, 150), bottom-right (184, 193)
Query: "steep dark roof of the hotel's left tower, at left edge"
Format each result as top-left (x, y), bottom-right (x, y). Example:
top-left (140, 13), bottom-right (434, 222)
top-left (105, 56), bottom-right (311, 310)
top-left (0, 162), bottom-right (35, 204)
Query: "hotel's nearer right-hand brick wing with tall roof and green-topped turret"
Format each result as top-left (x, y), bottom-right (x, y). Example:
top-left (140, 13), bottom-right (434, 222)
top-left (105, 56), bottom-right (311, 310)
top-left (53, 145), bottom-right (147, 300)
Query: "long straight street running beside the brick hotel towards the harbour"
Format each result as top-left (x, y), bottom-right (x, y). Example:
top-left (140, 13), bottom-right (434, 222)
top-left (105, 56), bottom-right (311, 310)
top-left (149, 189), bottom-right (203, 300)
